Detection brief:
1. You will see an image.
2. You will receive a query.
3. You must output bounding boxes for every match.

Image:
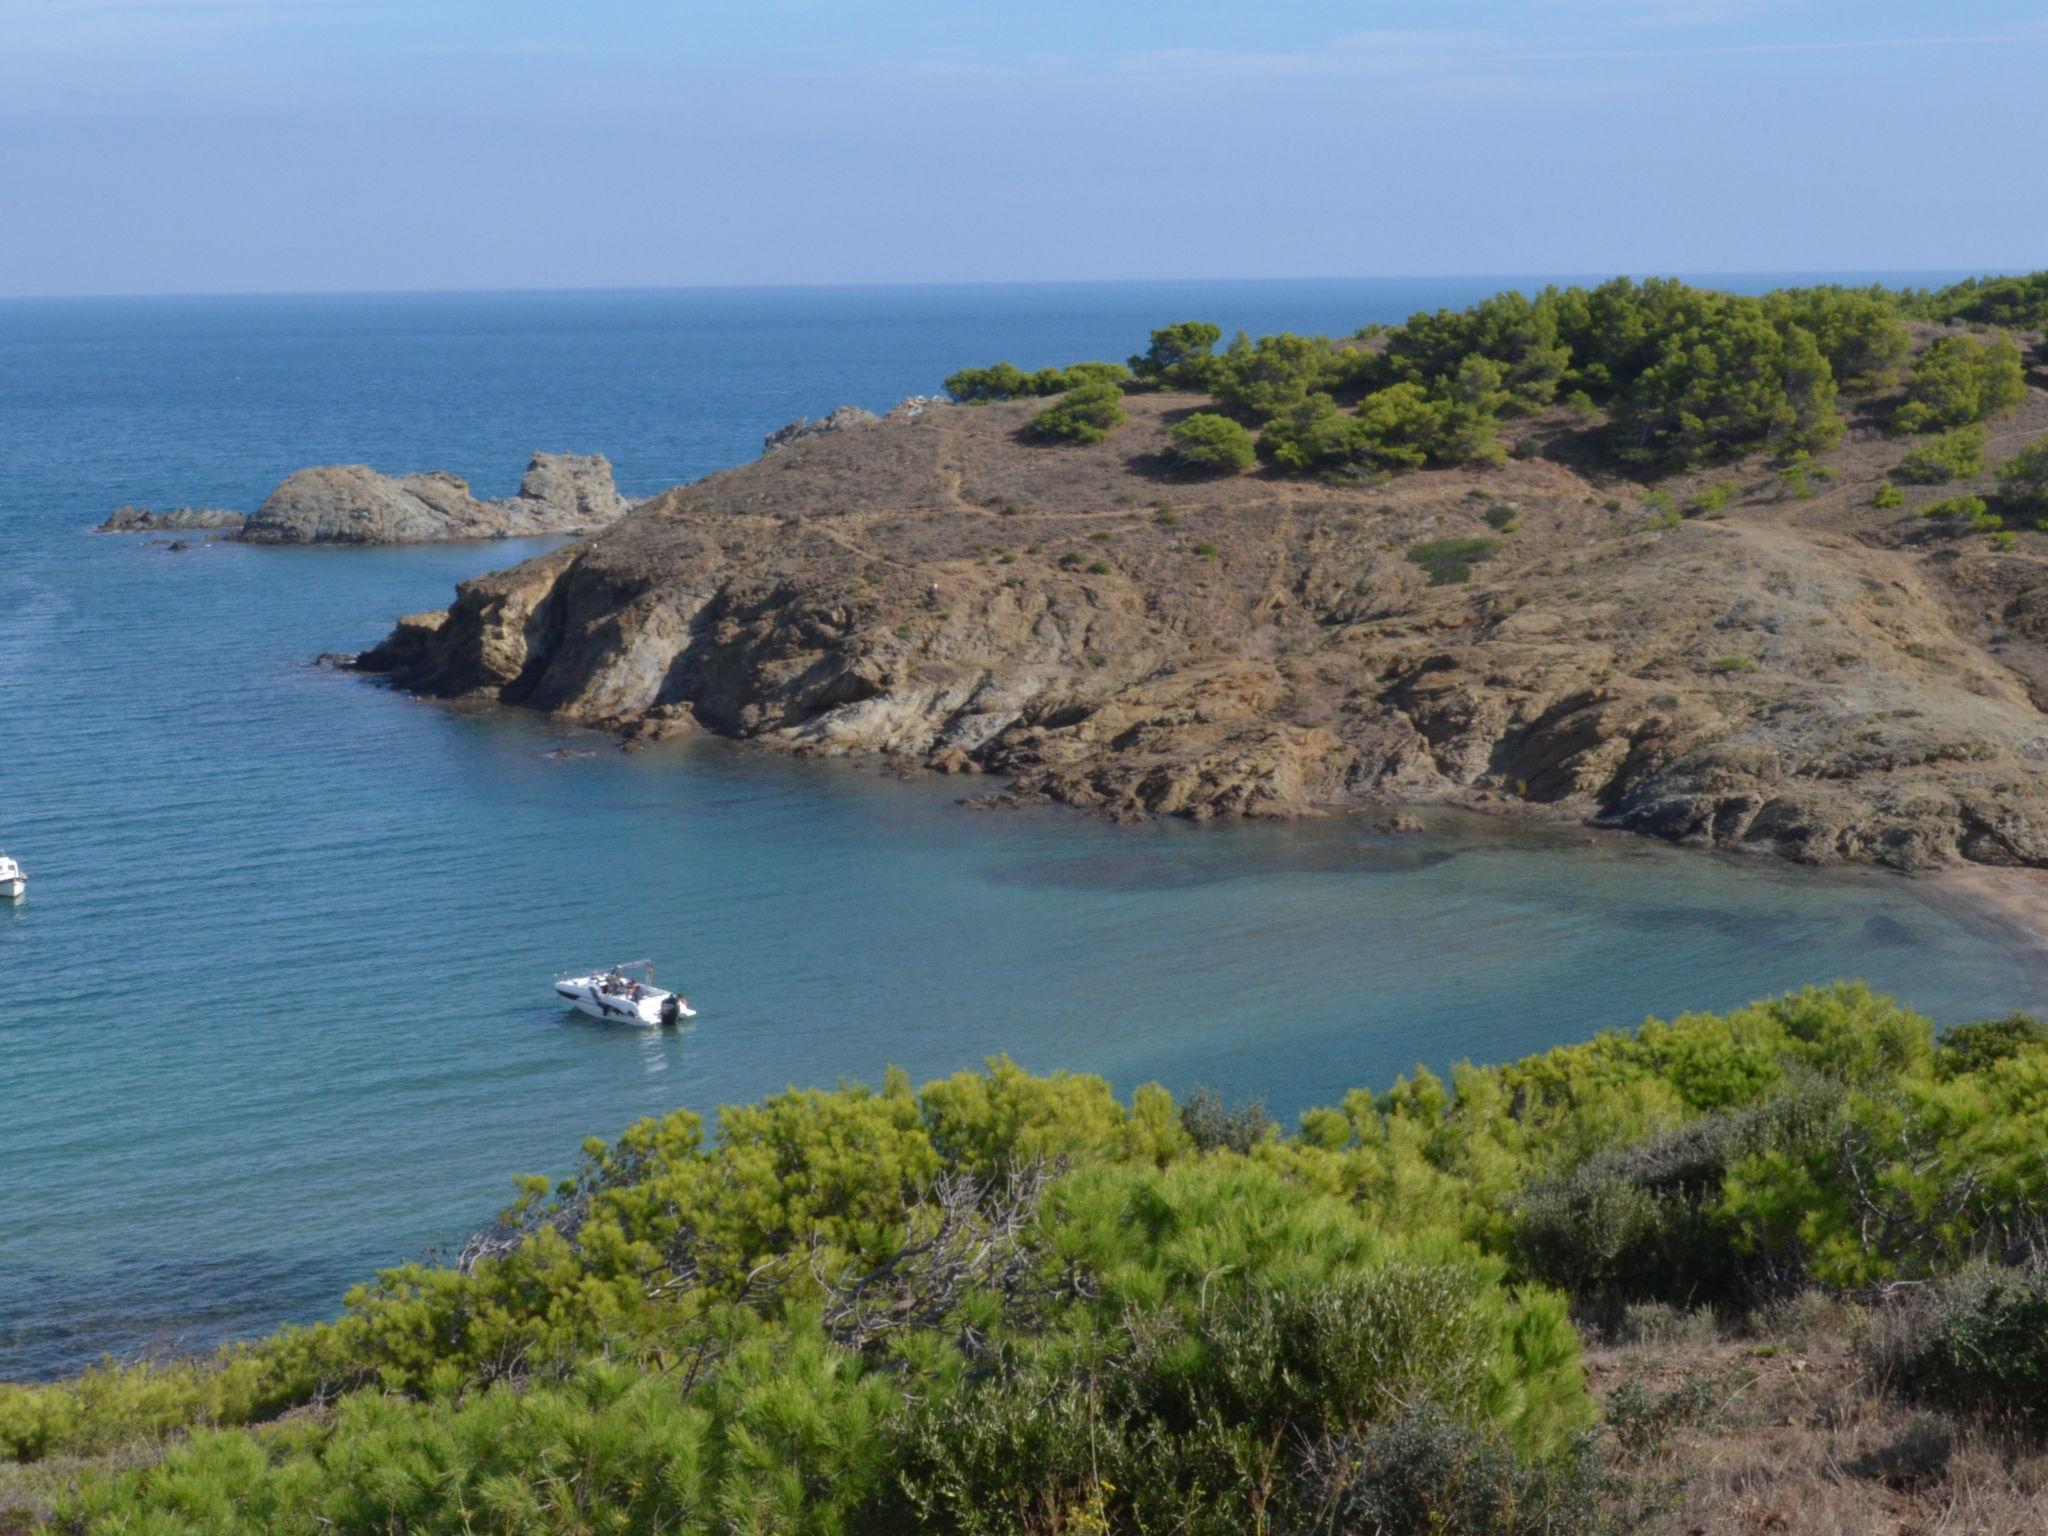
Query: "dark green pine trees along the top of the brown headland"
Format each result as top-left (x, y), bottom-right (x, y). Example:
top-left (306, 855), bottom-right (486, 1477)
top-left (1003, 274), bottom-right (2048, 493)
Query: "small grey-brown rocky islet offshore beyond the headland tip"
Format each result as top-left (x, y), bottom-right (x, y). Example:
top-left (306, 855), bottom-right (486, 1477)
top-left (100, 453), bottom-right (631, 545)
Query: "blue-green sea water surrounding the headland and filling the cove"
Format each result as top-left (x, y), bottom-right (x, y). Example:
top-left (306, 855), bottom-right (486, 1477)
top-left (0, 274), bottom-right (2044, 1378)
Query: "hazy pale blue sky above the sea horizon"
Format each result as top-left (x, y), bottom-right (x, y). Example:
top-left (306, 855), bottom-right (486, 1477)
top-left (0, 0), bottom-right (2048, 293)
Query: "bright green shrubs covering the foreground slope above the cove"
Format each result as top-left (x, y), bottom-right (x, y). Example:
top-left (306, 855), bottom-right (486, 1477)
top-left (19, 985), bottom-right (2048, 1536)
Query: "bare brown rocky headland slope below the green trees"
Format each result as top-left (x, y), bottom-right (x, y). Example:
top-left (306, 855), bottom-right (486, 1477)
top-left (360, 376), bottom-right (2048, 868)
